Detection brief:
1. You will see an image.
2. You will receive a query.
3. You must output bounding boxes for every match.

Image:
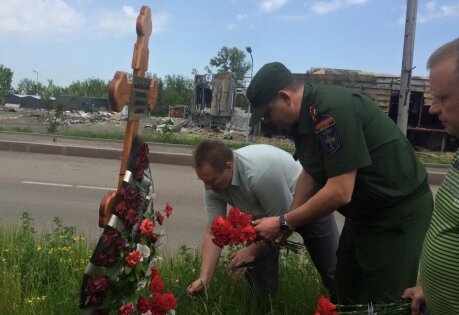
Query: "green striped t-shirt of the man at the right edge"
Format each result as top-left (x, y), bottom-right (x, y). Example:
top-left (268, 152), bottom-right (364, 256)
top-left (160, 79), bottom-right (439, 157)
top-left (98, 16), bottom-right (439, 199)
top-left (421, 151), bottom-right (459, 314)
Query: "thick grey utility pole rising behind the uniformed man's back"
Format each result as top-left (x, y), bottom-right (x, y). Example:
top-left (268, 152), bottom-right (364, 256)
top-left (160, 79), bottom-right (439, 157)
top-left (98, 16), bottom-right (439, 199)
top-left (397, 0), bottom-right (418, 135)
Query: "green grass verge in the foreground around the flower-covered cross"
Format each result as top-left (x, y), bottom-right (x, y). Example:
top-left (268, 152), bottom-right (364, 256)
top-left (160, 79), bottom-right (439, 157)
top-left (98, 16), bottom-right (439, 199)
top-left (0, 213), bottom-right (324, 315)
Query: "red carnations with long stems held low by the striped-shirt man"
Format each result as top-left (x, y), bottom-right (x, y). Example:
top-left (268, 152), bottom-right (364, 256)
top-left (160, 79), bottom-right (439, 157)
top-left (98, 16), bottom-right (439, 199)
top-left (314, 296), bottom-right (411, 315)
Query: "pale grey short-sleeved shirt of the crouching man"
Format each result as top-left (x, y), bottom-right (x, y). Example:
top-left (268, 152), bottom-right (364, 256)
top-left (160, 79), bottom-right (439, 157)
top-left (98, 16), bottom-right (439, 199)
top-left (205, 144), bottom-right (302, 224)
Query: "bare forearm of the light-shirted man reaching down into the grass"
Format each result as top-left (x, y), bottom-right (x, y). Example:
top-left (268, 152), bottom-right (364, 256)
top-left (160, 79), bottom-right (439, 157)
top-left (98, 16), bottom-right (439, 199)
top-left (186, 226), bottom-right (222, 294)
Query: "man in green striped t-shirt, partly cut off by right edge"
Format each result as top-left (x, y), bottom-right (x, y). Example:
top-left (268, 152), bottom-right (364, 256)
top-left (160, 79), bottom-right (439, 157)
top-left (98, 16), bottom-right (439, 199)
top-left (403, 38), bottom-right (459, 315)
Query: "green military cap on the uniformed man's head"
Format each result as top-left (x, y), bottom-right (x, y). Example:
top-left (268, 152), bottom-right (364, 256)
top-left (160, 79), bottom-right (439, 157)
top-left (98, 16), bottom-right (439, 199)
top-left (246, 62), bottom-right (293, 126)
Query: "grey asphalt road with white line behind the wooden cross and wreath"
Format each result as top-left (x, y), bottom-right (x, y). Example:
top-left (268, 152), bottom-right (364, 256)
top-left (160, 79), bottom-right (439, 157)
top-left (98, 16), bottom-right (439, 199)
top-left (0, 151), bottom-right (204, 251)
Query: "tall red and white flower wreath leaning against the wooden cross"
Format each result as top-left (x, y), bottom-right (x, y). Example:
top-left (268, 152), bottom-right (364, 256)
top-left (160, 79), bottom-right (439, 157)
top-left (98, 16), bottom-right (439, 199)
top-left (80, 141), bottom-right (176, 315)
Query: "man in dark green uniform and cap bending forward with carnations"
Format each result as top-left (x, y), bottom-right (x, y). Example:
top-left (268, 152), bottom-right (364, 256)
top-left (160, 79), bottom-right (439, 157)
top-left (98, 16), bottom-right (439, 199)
top-left (247, 62), bottom-right (433, 304)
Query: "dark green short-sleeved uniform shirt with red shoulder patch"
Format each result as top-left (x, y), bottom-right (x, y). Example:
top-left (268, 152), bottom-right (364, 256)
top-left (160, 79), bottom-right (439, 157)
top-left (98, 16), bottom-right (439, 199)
top-left (292, 85), bottom-right (429, 219)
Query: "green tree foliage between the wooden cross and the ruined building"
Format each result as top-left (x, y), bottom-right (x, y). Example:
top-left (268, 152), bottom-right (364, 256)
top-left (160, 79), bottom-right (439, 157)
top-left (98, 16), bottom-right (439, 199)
top-left (154, 75), bottom-right (193, 116)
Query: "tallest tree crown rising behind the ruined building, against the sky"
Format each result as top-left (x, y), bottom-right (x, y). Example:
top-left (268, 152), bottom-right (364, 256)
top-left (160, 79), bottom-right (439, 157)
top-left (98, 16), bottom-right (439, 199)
top-left (210, 46), bottom-right (250, 81)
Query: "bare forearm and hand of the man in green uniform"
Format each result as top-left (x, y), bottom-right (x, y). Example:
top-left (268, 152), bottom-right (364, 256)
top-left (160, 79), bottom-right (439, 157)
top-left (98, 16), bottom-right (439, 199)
top-left (253, 170), bottom-right (357, 241)
